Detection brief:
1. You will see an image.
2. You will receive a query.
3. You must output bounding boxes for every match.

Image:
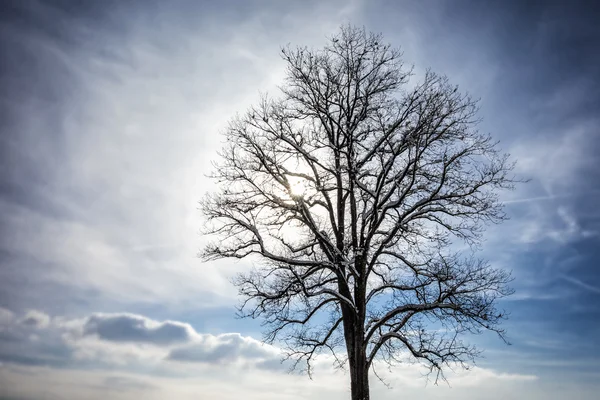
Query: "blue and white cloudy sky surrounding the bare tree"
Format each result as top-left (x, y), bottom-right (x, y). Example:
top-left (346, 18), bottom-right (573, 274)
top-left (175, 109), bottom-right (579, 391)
top-left (0, 0), bottom-right (600, 400)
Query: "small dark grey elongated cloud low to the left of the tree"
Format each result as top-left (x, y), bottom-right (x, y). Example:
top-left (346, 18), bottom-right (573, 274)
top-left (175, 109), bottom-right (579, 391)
top-left (83, 314), bottom-right (197, 345)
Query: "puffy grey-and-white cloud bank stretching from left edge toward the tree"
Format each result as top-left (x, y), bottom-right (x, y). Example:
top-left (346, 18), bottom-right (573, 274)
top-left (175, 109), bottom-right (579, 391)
top-left (0, 310), bottom-right (289, 373)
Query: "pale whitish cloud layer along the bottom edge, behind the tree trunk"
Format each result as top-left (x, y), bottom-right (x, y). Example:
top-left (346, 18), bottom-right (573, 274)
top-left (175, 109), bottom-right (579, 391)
top-left (0, 356), bottom-right (548, 400)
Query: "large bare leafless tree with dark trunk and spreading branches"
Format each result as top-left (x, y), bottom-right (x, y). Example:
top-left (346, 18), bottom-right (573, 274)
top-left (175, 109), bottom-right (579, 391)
top-left (201, 26), bottom-right (515, 400)
